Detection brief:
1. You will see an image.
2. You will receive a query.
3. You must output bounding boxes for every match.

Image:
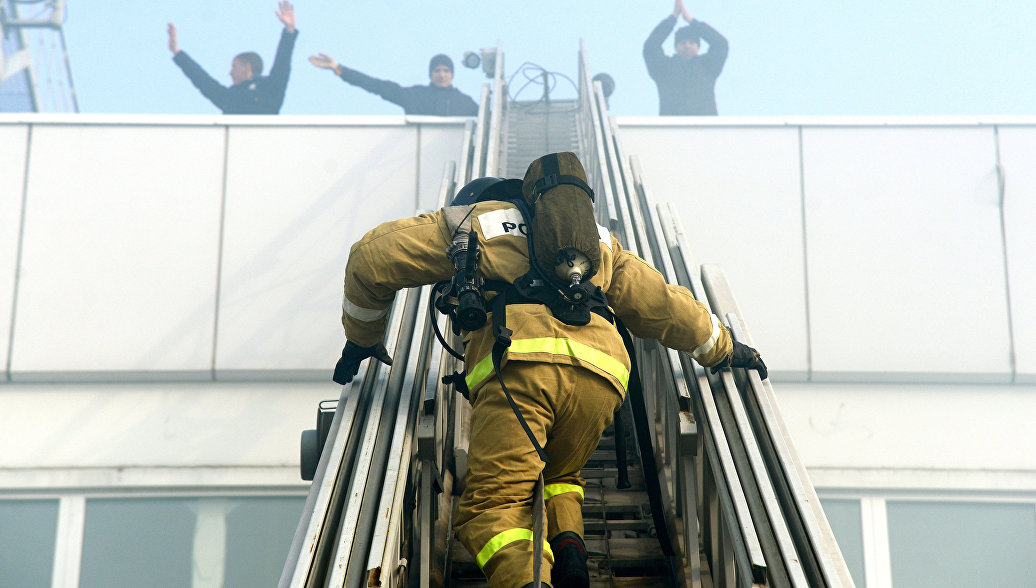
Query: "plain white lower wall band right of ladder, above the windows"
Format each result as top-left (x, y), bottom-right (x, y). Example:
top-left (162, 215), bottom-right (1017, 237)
top-left (775, 383), bottom-right (1036, 491)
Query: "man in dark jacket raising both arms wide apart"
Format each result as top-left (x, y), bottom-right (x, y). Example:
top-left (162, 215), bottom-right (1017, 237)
top-left (169, 0), bottom-right (298, 114)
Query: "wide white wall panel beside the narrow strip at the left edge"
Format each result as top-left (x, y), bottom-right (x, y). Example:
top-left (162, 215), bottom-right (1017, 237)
top-left (11, 125), bottom-right (224, 379)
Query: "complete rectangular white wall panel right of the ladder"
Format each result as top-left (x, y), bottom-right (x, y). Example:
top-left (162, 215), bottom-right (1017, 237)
top-left (803, 127), bottom-right (1009, 381)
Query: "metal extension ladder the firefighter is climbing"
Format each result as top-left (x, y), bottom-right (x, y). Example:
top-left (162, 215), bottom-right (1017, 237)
top-left (280, 42), bottom-right (853, 588)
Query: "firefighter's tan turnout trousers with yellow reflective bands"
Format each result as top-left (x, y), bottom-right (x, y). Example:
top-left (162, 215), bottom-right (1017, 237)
top-left (454, 361), bottom-right (623, 588)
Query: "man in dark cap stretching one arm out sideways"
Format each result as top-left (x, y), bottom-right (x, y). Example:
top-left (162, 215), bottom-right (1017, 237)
top-left (310, 53), bottom-right (479, 116)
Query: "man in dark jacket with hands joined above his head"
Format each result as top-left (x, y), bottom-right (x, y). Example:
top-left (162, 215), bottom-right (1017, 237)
top-left (643, 0), bottom-right (728, 116)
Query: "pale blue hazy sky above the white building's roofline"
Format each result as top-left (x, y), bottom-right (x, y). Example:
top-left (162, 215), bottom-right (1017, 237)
top-left (65, 0), bottom-right (1036, 115)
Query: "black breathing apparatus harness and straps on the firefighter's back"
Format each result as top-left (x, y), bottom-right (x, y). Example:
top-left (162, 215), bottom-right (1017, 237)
top-left (432, 157), bottom-right (614, 464)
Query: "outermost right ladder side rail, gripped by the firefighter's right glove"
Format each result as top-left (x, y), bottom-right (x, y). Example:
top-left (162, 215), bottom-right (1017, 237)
top-left (701, 265), bottom-right (854, 586)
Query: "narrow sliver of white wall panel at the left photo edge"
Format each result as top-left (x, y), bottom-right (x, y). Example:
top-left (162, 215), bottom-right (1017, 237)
top-left (0, 124), bottom-right (29, 380)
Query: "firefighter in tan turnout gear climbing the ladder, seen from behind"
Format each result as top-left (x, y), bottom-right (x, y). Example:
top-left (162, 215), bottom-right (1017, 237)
top-left (334, 153), bottom-right (766, 588)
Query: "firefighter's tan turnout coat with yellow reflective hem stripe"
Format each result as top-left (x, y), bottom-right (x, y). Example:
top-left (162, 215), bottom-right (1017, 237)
top-left (342, 201), bottom-right (731, 394)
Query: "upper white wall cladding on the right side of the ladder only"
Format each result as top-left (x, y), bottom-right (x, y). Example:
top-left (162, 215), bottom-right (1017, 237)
top-left (620, 119), bottom-right (1036, 382)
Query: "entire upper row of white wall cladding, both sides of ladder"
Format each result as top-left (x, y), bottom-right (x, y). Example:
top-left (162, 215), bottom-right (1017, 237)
top-left (0, 117), bottom-right (1036, 383)
